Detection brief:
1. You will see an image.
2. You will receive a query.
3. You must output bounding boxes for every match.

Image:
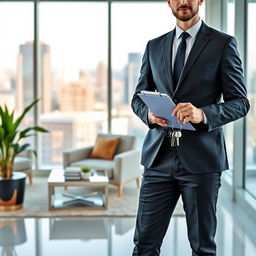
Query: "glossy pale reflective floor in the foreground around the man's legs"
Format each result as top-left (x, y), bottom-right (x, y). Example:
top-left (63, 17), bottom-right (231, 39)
top-left (0, 187), bottom-right (256, 256)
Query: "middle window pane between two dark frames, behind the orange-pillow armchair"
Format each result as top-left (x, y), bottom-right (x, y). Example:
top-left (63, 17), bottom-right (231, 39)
top-left (39, 2), bottom-right (108, 166)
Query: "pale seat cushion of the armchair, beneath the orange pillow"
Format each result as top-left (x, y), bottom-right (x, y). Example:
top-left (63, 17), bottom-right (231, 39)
top-left (71, 158), bottom-right (114, 179)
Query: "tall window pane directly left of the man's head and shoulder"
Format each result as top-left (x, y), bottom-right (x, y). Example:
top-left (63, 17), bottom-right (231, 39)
top-left (112, 2), bottom-right (175, 147)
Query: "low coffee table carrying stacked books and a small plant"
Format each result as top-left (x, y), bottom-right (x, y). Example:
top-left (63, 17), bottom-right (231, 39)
top-left (48, 169), bottom-right (109, 210)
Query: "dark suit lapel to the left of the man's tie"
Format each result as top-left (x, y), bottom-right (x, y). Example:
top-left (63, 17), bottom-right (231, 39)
top-left (163, 30), bottom-right (175, 95)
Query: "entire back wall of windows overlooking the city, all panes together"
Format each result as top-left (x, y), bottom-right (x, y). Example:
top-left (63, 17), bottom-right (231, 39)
top-left (0, 0), bottom-right (205, 168)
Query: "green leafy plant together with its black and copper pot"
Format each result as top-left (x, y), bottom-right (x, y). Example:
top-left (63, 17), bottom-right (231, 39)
top-left (0, 99), bottom-right (48, 211)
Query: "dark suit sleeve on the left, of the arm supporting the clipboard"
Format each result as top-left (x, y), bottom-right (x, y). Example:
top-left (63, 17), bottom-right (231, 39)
top-left (131, 41), bottom-right (158, 129)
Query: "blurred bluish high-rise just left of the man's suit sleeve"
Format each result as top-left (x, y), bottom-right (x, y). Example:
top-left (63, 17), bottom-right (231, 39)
top-left (124, 52), bottom-right (142, 104)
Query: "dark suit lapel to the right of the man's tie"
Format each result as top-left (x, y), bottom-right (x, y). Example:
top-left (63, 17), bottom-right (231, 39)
top-left (174, 23), bottom-right (214, 93)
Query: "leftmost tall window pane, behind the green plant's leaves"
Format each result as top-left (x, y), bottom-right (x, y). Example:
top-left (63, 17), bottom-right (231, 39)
top-left (0, 2), bottom-right (34, 147)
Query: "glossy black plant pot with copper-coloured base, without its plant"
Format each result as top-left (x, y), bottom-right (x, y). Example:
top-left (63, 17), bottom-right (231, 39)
top-left (0, 172), bottom-right (27, 211)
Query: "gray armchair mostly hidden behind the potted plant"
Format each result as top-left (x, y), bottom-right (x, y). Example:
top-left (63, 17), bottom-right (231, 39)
top-left (13, 149), bottom-right (33, 184)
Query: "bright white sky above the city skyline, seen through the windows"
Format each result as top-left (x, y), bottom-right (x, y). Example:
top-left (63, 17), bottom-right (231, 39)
top-left (8, 2), bottom-right (256, 84)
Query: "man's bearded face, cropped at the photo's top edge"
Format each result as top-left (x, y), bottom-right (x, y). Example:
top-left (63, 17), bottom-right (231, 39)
top-left (167, 0), bottom-right (204, 21)
